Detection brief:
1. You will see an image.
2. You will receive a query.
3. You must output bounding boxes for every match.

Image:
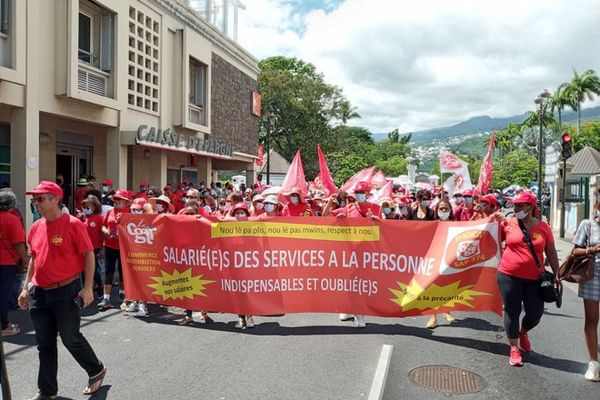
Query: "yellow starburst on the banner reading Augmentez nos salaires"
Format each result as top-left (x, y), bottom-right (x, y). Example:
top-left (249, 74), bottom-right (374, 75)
top-left (148, 268), bottom-right (216, 300)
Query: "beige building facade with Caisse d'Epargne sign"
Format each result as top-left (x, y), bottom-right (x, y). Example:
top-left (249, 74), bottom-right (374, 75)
top-left (0, 0), bottom-right (260, 225)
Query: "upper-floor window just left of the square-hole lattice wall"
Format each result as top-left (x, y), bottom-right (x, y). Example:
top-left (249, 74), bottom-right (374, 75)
top-left (77, 1), bottom-right (113, 72)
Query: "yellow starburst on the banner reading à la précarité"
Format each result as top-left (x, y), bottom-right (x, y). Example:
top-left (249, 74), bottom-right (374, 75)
top-left (390, 280), bottom-right (491, 311)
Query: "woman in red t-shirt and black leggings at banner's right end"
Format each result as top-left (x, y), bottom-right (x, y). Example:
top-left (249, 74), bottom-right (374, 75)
top-left (497, 192), bottom-right (562, 366)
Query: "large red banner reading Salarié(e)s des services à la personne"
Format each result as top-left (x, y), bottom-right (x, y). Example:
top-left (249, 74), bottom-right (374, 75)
top-left (118, 214), bottom-right (501, 316)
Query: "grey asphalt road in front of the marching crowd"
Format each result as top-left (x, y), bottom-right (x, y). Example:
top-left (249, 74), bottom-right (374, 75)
top-left (4, 236), bottom-right (600, 400)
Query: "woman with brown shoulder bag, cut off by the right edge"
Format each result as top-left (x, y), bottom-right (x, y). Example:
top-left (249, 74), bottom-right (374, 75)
top-left (572, 195), bottom-right (600, 382)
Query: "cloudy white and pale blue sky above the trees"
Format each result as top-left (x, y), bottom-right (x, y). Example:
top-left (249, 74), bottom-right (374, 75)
top-left (233, 0), bottom-right (600, 132)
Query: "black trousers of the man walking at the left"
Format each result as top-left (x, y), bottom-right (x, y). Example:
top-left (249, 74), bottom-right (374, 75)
top-left (29, 279), bottom-right (104, 396)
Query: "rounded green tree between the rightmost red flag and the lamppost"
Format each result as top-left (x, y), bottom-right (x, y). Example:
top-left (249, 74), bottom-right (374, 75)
top-left (492, 149), bottom-right (538, 188)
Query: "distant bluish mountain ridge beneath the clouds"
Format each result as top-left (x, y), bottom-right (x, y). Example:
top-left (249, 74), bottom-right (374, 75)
top-left (371, 106), bottom-right (600, 145)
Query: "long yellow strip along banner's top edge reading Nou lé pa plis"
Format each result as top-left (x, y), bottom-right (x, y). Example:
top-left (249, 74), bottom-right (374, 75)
top-left (210, 221), bottom-right (380, 242)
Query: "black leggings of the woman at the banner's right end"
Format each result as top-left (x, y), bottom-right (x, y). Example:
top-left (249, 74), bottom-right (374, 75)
top-left (496, 272), bottom-right (544, 339)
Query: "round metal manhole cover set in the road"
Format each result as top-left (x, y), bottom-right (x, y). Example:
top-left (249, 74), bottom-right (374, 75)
top-left (408, 365), bottom-right (487, 395)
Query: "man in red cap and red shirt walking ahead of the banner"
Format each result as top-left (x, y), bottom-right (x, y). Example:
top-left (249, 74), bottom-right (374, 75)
top-left (19, 181), bottom-right (106, 400)
